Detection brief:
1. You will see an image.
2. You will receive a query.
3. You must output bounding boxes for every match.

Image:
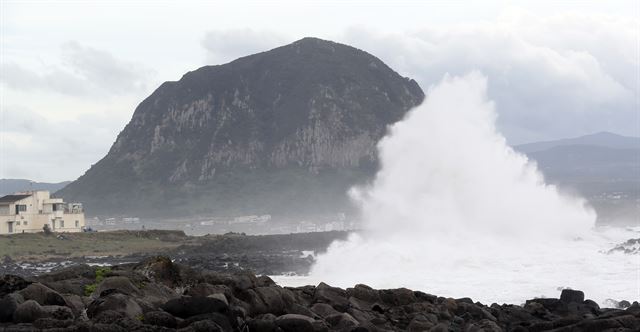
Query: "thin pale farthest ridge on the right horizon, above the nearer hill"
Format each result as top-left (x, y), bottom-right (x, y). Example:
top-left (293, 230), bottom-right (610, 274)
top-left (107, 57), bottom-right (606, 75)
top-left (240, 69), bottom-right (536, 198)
top-left (515, 131), bottom-right (640, 153)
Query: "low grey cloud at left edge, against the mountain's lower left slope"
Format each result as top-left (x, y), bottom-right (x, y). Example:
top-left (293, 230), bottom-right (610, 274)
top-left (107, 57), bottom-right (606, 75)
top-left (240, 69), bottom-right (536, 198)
top-left (0, 105), bottom-right (124, 181)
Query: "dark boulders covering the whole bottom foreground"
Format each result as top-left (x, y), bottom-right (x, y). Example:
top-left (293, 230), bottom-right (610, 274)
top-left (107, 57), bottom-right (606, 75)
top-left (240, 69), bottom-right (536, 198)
top-left (0, 257), bottom-right (640, 332)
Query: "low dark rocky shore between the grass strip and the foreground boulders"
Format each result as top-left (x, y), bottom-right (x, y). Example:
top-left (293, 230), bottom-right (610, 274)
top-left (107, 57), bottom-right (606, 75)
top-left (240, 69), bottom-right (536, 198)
top-left (0, 230), bottom-right (349, 277)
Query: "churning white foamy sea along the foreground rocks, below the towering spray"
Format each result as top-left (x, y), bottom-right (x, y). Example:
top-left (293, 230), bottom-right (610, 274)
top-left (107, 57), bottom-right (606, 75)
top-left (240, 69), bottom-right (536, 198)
top-left (271, 227), bottom-right (640, 307)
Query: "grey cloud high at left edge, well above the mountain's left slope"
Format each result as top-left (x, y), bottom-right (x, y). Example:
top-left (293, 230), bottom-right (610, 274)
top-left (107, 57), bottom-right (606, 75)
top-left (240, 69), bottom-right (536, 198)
top-left (0, 42), bottom-right (153, 96)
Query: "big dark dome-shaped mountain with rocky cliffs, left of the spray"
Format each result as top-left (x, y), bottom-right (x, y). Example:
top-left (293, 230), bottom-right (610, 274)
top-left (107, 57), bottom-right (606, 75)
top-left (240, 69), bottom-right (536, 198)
top-left (59, 38), bottom-right (424, 215)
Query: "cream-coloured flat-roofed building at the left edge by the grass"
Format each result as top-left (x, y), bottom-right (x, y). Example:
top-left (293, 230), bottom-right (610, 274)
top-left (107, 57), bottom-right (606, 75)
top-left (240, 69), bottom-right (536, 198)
top-left (0, 191), bottom-right (85, 234)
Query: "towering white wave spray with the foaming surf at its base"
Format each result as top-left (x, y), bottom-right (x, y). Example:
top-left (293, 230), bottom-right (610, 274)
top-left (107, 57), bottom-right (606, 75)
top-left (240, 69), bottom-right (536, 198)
top-left (305, 72), bottom-right (637, 304)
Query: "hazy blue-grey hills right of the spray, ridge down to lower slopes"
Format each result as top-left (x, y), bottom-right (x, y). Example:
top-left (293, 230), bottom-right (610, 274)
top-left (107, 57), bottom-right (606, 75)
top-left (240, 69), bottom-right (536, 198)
top-left (515, 132), bottom-right (640, 224)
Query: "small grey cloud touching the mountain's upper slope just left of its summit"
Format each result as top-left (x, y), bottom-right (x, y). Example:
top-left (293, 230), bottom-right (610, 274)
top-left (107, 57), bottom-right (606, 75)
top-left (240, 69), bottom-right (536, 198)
top-left (202, 29), bottom-right (289, 64)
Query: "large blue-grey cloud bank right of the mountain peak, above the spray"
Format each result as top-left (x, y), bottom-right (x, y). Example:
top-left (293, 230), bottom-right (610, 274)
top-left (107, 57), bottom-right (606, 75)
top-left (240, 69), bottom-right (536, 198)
top-left (344, 19), bottom-right (640, 144)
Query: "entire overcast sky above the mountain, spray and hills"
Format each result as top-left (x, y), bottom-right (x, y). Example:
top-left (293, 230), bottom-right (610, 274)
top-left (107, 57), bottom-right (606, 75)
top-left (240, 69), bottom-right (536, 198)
top-left (0, 0), bottom-right (640, 181)
